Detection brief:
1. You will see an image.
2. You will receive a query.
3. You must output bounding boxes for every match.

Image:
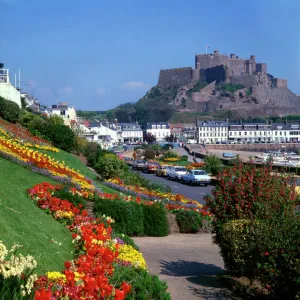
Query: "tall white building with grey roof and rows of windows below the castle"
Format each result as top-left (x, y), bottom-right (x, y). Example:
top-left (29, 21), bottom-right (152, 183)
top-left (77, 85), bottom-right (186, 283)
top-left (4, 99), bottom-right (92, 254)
top-left (197, 120), bottom-right (228, 144)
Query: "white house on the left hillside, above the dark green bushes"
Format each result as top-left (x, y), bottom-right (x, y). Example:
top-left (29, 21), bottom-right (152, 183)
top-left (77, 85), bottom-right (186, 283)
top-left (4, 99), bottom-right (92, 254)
top-left (43, 102), bottom-right (77, 128)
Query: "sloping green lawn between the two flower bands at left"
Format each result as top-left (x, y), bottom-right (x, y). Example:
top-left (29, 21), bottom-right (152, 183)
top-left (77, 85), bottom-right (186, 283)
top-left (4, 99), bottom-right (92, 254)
top-left (0, 158), bottom-right (74, 274)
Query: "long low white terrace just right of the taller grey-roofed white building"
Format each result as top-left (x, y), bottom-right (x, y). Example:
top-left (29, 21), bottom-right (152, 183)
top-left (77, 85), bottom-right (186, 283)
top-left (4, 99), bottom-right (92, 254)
top-left (228, 123), bottom-right (272, 143)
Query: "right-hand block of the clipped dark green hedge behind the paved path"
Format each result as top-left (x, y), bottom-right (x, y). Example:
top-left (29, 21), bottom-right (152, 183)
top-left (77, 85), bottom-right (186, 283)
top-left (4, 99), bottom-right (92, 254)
top-left (141, 204), bottom-right (169, 236)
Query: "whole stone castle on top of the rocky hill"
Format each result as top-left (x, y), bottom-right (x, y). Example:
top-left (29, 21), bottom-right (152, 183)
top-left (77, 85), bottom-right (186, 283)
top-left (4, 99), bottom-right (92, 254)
top-left (158, 50), bottom-right (287, 89)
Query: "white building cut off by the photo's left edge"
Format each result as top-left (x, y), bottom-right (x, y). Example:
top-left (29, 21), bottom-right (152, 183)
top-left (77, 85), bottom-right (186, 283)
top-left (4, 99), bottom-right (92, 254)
top-left (0, 69), bottom-right (22, 107)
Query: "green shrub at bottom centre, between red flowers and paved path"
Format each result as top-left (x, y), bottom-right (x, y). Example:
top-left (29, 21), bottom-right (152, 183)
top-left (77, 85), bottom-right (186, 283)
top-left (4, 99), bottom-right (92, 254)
top-left (110, 266), bottom-right (171, 300)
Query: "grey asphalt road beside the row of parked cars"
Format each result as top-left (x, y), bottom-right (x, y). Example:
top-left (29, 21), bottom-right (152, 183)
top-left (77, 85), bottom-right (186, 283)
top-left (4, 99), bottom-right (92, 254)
top-left (135, 172), bottom-right (214, 205)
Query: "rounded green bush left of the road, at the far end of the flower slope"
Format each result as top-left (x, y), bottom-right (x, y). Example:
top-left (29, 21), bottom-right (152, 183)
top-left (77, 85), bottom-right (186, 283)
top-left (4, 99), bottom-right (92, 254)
top-left (95, 153), bottom-right (128, 179)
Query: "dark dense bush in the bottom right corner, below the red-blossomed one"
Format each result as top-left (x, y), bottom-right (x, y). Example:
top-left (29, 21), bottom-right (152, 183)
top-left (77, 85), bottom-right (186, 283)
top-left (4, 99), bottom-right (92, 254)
top-left (221, 217), bottom-right (300, 299)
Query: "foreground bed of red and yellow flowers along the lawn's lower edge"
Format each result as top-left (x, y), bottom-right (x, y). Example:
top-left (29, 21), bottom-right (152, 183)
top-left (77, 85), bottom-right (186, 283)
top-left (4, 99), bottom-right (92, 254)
top-left (28, 183), bottom-right (152, 300)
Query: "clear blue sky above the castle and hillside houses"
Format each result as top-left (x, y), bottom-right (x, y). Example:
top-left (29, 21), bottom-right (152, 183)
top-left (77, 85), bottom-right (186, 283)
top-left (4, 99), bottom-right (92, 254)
top-left (0, 0), bottom-right (300, 110)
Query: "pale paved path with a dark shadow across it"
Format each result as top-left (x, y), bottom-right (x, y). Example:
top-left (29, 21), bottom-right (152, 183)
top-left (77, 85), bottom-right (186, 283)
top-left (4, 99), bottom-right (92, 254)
top-left (134, 234), bottom-right (236, 300)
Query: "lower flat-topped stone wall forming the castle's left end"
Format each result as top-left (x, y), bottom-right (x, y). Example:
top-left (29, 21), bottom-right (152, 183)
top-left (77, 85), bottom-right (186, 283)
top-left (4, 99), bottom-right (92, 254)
top-left (157, 67), bottom-right (192, 87)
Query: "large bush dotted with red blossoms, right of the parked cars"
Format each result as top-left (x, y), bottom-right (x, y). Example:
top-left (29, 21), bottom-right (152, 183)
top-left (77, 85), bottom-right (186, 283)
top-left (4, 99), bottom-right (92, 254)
top-left (205, 161), bottom-right (296, 234)
